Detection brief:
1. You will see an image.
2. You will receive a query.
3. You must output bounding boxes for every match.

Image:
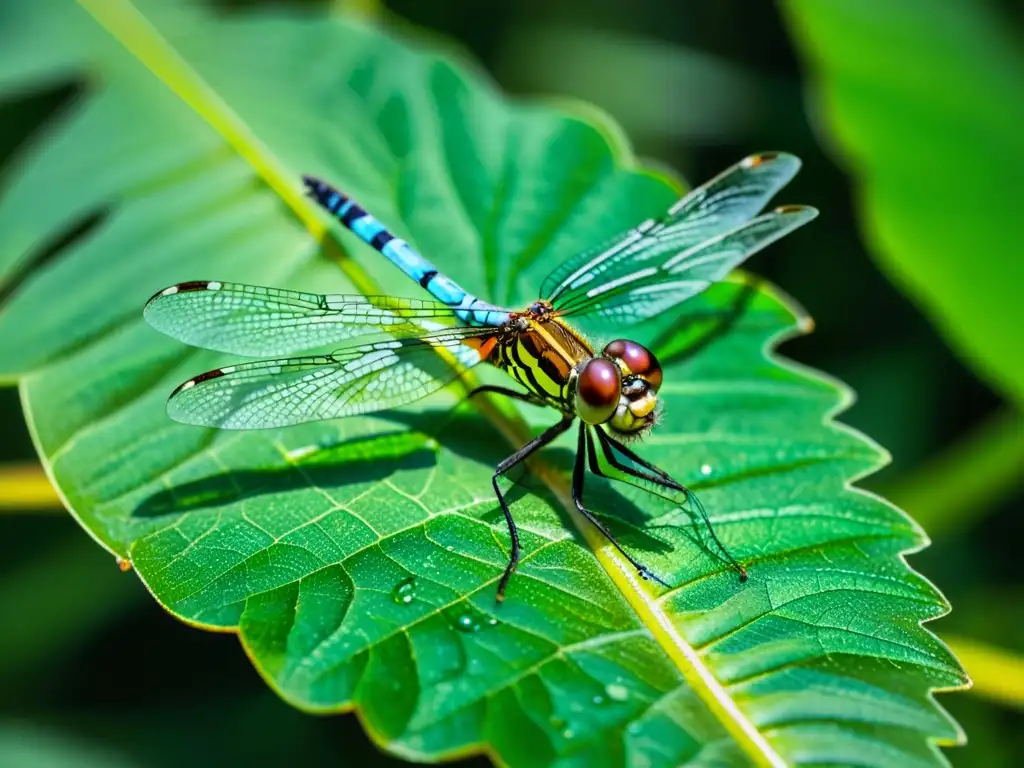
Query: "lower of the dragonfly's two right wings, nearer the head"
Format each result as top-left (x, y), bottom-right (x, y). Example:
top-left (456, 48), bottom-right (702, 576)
top-left (554, 206), bottom-right (818, 325)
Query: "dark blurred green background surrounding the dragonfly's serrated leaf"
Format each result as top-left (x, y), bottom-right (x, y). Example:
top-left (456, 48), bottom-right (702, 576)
top-left (0, 0), bottom-right (1024, 766)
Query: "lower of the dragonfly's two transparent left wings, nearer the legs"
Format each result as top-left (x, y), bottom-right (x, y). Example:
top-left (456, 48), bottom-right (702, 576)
top-left (167, 328), bottom-right (494, 429)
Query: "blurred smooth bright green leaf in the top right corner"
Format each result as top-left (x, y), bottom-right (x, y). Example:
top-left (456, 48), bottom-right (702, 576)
top-left (783, 0), bottom-right (1024, 404)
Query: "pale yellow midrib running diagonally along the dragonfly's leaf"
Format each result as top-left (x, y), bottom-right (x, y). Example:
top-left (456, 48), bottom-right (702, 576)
top-left (72, 0), bottom-right (785, 767)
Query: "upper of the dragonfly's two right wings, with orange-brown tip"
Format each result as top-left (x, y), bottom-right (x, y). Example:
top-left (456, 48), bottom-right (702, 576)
top-left (541, 153), bottom-right (800, 316)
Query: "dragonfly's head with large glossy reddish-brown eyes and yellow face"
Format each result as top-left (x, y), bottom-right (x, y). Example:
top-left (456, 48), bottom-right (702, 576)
top-left (575, 339), bottom-right (662, 435)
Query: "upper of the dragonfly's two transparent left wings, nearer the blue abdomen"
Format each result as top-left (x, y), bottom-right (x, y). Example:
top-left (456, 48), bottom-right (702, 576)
top-left (143, 281), bottom-right (483, 357)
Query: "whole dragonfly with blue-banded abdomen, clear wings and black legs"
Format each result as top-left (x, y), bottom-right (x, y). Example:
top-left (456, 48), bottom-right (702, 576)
top-left (143, 153), bottom-right (817, 602)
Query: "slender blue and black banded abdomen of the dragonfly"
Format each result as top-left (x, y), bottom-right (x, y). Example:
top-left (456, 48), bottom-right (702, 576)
top-left (303, 176), bottom-right (509, 326)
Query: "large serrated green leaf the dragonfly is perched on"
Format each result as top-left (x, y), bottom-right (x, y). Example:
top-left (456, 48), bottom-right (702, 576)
top-left (0, 0), bottom-right (965, 766)
